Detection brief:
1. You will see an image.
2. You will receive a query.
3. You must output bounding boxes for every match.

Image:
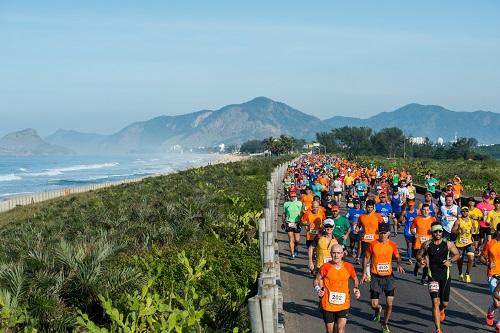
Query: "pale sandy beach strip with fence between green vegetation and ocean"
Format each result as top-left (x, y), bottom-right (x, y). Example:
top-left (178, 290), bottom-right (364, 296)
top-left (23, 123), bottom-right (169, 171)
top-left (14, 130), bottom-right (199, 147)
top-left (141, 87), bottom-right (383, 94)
top-left (0, 153), bottom-right (250, 213)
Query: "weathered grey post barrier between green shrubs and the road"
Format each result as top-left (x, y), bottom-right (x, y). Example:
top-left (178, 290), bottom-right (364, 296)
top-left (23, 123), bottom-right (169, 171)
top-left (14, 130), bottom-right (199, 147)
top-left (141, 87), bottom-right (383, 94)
top-left (248, 163), bottom-right (289, 333)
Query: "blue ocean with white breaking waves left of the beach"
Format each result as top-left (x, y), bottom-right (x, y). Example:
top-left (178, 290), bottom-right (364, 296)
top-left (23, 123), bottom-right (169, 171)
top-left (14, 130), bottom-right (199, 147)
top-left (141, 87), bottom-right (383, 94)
top-left (0, 153), bottom-right (217, 200)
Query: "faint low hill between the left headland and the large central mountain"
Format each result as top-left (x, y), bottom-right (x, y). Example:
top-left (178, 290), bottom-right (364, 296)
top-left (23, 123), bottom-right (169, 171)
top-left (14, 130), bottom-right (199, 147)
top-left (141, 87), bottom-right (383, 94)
top-left (45, 129), bottom-right (106, 154)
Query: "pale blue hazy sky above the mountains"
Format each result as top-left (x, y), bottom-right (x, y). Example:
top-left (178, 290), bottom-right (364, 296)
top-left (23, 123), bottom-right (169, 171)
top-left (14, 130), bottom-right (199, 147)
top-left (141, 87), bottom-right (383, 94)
top-left (0, 0), bottom-right (500, 136)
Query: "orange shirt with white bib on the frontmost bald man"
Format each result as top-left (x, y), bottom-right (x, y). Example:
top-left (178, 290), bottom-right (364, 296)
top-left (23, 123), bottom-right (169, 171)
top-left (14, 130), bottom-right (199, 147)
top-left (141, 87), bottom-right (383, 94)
top-left (319, 261), bottom-right (356, 312)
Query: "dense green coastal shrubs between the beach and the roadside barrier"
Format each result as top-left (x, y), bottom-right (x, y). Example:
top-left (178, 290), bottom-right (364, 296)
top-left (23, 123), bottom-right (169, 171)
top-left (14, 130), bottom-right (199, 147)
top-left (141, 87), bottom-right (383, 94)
top-left (0, 157), bottom-right (287, 332)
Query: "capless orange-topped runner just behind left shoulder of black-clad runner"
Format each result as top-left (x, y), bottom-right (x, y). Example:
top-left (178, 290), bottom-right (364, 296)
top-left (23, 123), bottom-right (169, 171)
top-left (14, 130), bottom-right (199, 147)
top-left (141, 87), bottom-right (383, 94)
top-left (410, 204), bottom-right (436, 285)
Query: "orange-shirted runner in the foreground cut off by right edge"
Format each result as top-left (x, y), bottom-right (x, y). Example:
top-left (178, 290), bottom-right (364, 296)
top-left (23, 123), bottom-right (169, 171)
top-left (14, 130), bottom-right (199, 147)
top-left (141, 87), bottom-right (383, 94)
top-left (480, 224), bottom-right (500, 333)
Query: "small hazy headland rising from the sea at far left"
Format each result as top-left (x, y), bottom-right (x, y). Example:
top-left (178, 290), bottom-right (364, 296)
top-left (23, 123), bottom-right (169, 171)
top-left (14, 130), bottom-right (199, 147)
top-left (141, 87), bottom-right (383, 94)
top-left (0, 128), bottom-right (72, 155)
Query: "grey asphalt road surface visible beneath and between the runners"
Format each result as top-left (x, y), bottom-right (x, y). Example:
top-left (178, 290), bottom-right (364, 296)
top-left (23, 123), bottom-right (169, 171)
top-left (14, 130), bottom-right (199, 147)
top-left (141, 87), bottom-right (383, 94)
top-left (278, 191), bottom-right (498, 333)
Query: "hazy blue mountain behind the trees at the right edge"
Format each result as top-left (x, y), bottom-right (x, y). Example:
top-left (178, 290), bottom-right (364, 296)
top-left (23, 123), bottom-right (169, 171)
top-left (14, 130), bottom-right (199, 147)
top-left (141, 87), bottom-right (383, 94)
top-left (323, 103), bottom-right (500, 144)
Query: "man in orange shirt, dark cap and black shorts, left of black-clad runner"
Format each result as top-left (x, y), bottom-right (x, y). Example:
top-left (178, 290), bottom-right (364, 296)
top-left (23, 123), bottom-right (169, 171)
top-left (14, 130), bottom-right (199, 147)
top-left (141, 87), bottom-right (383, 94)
top-left (361, 223), bottom-right (405, 333)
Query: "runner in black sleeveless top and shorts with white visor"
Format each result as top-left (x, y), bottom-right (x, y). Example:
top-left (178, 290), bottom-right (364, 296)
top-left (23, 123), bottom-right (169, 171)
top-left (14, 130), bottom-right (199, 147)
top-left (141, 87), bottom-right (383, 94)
top-left (417, 222), bottom-right (460, 333)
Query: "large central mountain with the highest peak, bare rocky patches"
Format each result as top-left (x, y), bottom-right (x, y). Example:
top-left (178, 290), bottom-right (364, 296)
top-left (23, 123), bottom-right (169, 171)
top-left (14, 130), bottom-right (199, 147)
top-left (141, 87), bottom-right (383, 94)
top-left (96, 97), bottom-right (326, 153)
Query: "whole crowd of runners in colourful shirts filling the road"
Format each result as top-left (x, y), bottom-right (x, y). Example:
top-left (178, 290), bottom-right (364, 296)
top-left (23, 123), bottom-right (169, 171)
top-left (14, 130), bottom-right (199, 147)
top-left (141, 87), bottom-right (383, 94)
top-left (282, 155), bottom-right (500, 333)
